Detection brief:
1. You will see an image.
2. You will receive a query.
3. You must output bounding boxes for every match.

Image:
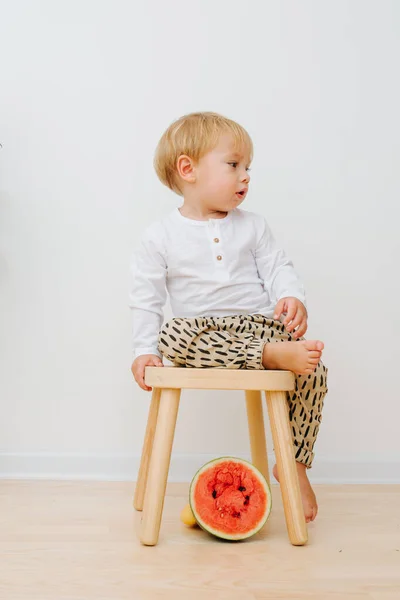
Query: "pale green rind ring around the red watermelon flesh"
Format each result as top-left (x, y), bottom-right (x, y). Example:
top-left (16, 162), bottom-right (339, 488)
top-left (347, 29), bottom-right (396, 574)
top-left (189, 456), bottom-right (272, 541)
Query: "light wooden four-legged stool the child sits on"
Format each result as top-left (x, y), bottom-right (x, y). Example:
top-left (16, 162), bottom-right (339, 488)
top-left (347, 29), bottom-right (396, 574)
top-left (134, 367), bottom-right (307, 546)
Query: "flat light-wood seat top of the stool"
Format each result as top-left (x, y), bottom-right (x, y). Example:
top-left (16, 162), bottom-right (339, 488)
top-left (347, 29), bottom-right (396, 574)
top-left (145, 367), bottom-right (294, 392)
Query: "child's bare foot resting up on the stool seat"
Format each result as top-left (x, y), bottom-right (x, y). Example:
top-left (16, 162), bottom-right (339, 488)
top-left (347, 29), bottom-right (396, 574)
top-left (263, 340), bottom-right (324, 374)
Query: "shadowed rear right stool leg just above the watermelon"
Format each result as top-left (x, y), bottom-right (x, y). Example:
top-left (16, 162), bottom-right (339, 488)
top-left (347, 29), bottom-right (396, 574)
top-left (246, 390), bottom-right (271, 484)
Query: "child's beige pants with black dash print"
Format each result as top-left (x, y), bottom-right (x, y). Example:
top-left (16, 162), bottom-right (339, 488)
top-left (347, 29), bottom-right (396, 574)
top-left (158, 315), bottom-right (328, 468)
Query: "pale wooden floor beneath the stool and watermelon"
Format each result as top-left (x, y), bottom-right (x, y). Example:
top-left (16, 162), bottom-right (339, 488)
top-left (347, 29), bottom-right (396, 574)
top-left (0, 481), bottom-right (400, 600)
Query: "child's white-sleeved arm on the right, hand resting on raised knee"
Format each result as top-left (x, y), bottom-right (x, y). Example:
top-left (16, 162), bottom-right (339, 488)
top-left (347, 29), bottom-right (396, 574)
top-left (255, 219), bottom-right (307, 338)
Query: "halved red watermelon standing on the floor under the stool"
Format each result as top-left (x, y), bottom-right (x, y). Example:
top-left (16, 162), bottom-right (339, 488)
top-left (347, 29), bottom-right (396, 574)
top-left (189, 456), bottom-right (272, 540)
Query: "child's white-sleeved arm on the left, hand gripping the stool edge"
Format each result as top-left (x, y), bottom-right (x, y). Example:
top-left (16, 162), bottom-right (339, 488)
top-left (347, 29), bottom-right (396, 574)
top-left (129, 230), bottom-right (167, 391)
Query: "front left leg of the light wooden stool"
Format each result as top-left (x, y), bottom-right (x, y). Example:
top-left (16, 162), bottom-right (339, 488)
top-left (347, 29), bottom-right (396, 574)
top-left (140, 389), bottom-right (181, 546)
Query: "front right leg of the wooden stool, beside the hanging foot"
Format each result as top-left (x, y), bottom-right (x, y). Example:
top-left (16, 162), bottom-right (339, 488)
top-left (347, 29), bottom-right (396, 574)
top-left (265, 392), bottom-right (308, 546)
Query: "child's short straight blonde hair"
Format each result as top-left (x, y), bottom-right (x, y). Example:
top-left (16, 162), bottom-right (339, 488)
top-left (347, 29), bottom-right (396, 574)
top-left (154, 112), bottom-right (253, 196)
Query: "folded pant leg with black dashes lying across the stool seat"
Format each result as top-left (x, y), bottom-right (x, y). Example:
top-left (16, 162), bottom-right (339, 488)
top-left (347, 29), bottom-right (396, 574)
top-left (158, 316), bottom-right (265, 369)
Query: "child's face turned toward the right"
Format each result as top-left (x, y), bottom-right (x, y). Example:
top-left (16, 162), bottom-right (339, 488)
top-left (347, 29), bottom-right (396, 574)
top-left (195, 134), bottom-right (250, 211)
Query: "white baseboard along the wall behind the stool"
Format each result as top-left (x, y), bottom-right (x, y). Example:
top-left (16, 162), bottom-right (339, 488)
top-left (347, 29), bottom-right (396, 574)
top-left (0, 452), bottom-right (400, 484)
